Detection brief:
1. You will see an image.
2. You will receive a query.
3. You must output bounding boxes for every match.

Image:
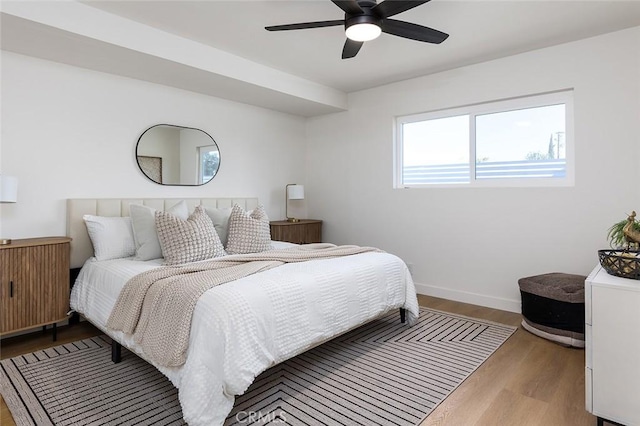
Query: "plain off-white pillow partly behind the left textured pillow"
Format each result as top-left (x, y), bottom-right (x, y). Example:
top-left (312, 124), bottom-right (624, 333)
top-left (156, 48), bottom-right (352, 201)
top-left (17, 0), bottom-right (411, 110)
top-left (129, 200), bottom-right (189, 260)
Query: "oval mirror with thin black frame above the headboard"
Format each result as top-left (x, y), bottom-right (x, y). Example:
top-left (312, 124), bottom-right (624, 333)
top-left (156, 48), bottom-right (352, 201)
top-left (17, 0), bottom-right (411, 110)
top-left (136, 124), bottom-right (220, 185)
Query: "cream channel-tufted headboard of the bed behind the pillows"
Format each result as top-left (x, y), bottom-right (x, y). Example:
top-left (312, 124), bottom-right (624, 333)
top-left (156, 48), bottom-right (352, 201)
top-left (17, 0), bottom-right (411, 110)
top-left (67, 198), bottom-right (258, 268)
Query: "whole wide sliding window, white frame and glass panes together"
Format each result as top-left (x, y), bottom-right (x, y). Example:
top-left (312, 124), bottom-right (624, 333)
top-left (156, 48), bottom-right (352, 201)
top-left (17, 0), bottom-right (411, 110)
top-left (395, 91), bottom-right (573, 188)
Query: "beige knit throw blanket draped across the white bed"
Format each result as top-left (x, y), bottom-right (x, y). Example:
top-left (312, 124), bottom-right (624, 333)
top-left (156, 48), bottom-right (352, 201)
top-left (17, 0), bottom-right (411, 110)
top-left (107, 243), bottom-right (380, 367)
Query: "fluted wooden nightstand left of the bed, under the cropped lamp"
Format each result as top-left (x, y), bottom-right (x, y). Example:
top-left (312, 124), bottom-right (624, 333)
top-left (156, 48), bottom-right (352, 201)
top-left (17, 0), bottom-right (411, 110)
top-left (0, 237), bottom-right (71, 340)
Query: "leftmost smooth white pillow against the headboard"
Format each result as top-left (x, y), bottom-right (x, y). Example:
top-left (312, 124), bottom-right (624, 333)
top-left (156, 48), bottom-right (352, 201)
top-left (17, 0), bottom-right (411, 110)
top-left (82, 214), bottom-right (136, 260)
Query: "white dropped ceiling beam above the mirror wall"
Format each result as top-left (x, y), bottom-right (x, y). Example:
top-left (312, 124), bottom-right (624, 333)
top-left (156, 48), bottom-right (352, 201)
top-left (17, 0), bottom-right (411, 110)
top-left (1, 2), bottom-right (347, 116)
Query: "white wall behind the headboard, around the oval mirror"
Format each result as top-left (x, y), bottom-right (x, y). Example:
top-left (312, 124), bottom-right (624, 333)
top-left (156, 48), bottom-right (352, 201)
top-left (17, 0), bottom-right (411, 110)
top-left (0, 51), bottom-right (305, 238)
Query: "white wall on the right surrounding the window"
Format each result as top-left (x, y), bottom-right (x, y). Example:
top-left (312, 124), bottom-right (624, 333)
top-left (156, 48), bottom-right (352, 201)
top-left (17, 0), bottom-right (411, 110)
top-left (307, 27), bottom-right (640, 311)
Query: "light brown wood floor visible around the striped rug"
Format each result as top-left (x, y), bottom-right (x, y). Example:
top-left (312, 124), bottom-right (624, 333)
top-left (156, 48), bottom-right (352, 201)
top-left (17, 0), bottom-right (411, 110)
top-left (0, 296), bottom-right (596, 426)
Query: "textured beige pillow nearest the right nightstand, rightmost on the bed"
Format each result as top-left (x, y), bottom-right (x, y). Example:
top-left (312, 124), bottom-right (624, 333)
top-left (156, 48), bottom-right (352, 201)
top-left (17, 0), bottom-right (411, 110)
top-left (226, 204), bottom-right (271, 254)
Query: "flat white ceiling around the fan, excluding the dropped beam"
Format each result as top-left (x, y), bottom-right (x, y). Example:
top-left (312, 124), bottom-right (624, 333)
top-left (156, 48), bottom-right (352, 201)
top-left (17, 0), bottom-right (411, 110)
top-left (81, 0), bottom-right (640, 92)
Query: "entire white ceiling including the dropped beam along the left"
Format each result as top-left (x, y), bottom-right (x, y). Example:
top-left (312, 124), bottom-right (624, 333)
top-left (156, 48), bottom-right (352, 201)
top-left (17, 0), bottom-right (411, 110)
top-left (0, 0), bottom-right (640, 116)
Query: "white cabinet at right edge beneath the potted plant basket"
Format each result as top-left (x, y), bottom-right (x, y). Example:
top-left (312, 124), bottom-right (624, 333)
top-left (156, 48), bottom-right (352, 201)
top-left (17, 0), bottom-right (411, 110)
top-left (585, 265), bottom-right (640, 426)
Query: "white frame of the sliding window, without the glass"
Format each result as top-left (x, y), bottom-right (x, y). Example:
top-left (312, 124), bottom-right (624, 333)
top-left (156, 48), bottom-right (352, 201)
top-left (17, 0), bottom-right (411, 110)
top-left (393, 89), bottom-right (575, 189)
